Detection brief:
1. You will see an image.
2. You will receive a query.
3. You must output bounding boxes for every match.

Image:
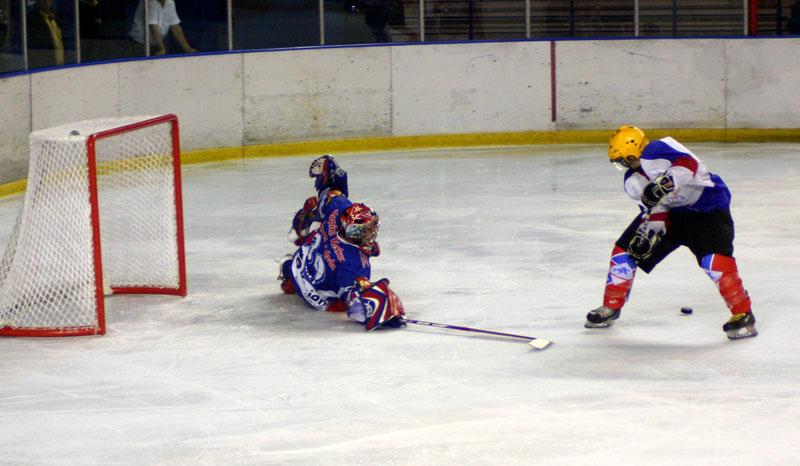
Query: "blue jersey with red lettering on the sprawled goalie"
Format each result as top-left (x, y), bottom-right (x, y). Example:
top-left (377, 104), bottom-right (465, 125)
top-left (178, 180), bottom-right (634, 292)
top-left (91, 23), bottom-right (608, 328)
top-left (291, 190), bottom-right (370, 311)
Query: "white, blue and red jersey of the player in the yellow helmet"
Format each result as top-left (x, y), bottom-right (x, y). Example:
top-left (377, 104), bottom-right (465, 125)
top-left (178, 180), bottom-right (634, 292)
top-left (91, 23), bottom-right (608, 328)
top-left (625, 137), bottom-right (731, 212)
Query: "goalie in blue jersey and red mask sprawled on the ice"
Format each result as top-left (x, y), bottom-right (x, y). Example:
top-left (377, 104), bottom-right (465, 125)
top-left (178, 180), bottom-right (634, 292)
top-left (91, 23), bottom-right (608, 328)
top-left (279, 155), bottom-right (405, 330)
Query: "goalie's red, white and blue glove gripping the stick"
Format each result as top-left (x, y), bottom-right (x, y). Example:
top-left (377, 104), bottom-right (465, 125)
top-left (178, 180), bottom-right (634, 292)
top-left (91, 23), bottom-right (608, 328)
top-left (347, 277), bottom-right (406, 331)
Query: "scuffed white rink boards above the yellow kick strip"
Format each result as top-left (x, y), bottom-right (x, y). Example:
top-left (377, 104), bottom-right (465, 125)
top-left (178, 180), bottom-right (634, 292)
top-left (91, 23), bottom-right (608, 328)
top-left (0, 38), bottom-right (800, 183)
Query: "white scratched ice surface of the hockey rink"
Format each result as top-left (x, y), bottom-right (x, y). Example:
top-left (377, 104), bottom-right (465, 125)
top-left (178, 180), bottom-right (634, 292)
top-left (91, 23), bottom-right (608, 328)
top-left (0, 144), bottom-right (800, 465)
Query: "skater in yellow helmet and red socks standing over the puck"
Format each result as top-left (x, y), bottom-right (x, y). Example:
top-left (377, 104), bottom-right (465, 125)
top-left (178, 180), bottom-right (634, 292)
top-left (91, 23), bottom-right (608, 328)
top-left (585, 126), bottom-right (758, 339)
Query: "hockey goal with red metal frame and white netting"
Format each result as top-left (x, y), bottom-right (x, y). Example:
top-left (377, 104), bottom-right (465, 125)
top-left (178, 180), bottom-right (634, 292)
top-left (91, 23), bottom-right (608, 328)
top-left (0, 115), bottom-right (186, 336)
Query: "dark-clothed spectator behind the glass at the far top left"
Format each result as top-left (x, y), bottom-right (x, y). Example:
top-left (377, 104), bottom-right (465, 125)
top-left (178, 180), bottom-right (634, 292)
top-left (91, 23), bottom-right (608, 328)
top-left (28, 0), bottom-right (64, 68)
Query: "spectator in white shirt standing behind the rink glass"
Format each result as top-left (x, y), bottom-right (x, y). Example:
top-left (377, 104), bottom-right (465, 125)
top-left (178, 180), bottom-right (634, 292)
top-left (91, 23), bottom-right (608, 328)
top-left (130, 0), bottom-right (197, 55)
